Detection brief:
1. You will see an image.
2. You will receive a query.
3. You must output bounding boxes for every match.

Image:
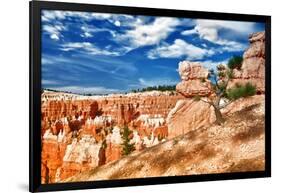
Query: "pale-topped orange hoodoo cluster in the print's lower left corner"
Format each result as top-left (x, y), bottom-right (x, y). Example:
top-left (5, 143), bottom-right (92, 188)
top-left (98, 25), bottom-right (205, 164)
top-left (41, 132), bottom-right (105, 183)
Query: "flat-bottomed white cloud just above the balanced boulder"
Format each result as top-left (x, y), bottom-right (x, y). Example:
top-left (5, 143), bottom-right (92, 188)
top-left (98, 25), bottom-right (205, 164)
top-left (148, 39), bottom-right (214, 60)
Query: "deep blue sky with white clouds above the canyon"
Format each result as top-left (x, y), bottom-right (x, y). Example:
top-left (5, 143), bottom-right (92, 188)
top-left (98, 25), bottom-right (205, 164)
top-left (41, 10), bottom-right (264, 94)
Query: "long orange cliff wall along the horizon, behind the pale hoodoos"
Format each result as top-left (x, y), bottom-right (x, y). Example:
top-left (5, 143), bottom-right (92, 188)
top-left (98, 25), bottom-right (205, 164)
top-left (42, 91), bottom-right (183, 124)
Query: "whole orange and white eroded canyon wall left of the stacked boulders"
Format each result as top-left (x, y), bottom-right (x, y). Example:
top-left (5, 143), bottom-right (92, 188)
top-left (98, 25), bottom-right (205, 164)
top-left (42, 91), bottom-right (183, 183)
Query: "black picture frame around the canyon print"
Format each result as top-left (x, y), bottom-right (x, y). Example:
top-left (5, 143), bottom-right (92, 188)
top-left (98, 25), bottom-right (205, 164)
top-left (29, 1), bottom-right (271, 192)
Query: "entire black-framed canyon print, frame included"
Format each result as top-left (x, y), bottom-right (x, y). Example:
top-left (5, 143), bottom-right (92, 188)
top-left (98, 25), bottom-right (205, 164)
top-left (29, 1), bottom-right (271, 192)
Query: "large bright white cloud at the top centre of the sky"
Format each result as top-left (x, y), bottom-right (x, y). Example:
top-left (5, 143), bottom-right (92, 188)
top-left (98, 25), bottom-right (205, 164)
top-left (116, 17), bottom-right (180, 48)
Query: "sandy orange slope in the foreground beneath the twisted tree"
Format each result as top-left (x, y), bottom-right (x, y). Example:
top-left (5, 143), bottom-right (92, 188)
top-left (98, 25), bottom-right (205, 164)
top-left (64, 95), bottom-right (265, 182)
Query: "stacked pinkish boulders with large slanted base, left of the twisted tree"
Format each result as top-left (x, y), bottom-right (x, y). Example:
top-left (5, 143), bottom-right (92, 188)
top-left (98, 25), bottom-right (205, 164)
top-left (167, 61), bottom-right (215, 138)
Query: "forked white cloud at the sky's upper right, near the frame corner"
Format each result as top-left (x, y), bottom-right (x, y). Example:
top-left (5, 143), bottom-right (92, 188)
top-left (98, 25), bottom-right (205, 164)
top-left (181, 19), bottom-right (255, 51)
